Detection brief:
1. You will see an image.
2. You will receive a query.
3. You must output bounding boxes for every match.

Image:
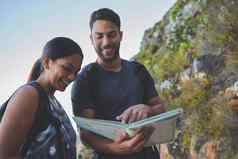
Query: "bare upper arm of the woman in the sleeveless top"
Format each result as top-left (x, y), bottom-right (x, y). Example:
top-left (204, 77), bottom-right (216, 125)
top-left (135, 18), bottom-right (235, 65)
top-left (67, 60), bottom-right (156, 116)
top-left (0, 86), bottom-right (39, 159)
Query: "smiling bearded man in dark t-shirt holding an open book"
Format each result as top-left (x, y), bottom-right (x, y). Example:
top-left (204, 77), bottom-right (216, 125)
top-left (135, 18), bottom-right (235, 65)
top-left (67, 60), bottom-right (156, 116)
top-left (71, 8), bottom-right (165, 159)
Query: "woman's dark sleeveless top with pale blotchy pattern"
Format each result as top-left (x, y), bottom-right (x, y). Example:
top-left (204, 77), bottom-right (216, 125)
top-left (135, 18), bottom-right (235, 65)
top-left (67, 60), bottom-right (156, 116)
top-left (20, 81), bottom-right (76, 159)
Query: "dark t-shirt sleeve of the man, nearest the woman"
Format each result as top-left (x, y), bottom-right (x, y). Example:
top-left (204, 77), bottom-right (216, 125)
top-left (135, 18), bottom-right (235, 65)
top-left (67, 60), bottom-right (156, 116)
top-left (71, 66), bottom-right (94, 116)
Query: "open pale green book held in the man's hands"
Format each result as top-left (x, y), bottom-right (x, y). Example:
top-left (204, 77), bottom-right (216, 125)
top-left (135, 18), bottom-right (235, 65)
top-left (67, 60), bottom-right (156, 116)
top-left (73, 108), bottom-right (183, 146)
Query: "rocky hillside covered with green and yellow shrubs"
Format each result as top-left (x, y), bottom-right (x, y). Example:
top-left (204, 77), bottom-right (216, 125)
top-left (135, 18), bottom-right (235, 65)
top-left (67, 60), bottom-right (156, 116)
top-left (134, 0), bottom-right (238, 159)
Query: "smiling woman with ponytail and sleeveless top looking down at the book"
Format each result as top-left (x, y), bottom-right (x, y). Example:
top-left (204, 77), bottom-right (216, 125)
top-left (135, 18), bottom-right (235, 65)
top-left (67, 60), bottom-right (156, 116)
top-left (0, 37), bottom-right (83, 159)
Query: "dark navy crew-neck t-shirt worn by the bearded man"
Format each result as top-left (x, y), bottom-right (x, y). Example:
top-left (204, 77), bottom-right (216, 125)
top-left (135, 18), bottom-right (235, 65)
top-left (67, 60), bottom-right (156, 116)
top-left (71, 60), bottom-right (158, 159)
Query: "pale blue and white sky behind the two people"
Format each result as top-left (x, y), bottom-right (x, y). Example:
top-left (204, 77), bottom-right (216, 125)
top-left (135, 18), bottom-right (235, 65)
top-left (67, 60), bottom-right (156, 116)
top-left (0, 0), bottom-right (176, 114)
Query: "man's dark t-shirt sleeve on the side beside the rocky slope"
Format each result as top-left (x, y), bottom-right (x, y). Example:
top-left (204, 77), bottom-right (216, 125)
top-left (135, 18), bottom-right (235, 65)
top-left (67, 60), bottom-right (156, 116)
top-left (138, 64), bottom-right (158, 103)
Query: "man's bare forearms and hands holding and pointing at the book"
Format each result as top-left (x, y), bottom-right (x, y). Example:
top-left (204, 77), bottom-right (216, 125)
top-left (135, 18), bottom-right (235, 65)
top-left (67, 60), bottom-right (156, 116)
top-left (81, 96), bottom-right (165, 155)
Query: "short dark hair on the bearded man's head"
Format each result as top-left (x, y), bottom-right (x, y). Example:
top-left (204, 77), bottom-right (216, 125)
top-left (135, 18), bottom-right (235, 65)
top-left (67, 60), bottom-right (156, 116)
top-left (89, 8), bottom-right (121, 30)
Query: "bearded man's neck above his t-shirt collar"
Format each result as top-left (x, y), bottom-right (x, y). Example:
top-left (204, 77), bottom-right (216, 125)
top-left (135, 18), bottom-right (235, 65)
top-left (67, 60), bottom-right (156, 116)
top-left (96, 57), bottom-right (122, 72)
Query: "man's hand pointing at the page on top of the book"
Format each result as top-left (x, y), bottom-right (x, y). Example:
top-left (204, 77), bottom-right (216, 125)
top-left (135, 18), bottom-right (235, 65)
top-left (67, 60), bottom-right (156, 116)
top-left (116, 104), bottom-right (151, 123)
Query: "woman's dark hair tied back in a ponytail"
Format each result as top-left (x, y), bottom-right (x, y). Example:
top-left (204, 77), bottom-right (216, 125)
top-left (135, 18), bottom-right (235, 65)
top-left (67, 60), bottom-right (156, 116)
top-left (28, 37), bottom-right (83, 82)
